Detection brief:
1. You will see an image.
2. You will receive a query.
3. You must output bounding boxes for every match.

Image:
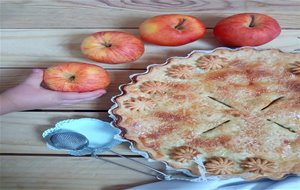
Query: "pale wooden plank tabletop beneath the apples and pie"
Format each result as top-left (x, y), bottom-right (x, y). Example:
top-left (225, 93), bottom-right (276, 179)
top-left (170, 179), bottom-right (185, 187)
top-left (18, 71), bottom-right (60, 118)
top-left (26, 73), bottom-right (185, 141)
top-left (0, 0), bottom-right (300, 190)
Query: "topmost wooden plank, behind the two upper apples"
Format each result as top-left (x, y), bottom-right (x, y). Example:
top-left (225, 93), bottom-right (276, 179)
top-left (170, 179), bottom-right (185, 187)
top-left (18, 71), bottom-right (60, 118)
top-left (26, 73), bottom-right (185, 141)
top-left (1, 0), bottom-right (300, 28)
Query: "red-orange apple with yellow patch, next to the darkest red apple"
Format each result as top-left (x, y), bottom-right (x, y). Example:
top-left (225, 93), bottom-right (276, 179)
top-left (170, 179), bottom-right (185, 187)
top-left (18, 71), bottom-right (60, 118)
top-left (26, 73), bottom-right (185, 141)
top-left (139, 14), bottom-right (205, 46)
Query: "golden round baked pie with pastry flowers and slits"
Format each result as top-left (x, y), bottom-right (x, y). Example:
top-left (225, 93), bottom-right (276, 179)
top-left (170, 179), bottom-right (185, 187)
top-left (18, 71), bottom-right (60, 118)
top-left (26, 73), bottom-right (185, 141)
top-left (111, 48), bottom-right (300, 179)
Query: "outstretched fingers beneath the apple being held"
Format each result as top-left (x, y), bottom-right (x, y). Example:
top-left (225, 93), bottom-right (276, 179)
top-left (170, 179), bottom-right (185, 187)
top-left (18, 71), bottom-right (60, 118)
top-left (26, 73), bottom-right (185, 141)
top-left (59, 89), bottom-right (106, 101)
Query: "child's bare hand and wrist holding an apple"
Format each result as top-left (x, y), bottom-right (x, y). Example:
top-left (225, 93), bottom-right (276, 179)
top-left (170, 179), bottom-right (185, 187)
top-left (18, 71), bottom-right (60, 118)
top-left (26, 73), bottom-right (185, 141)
top-left (0, 69), bottom-right (106, 115)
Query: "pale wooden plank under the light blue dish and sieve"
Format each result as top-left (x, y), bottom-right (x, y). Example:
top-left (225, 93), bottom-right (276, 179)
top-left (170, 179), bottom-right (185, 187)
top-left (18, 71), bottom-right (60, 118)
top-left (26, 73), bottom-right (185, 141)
top-left (0, 112), bottom-right (136, 155)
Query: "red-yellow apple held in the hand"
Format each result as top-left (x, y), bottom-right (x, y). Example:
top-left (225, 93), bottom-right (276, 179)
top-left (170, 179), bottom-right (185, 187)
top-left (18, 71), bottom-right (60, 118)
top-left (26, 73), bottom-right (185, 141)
top-left (43, 62), bottom-right (110, 92)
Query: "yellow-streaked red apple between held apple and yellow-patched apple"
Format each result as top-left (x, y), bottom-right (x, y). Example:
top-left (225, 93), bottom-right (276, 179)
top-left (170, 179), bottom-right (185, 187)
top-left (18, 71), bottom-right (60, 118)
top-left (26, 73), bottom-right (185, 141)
top-left (81, 31), bottom-right (144, 64)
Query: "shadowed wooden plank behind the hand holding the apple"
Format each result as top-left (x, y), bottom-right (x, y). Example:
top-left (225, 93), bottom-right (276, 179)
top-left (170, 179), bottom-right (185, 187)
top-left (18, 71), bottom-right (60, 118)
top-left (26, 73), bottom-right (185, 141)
top-left (0, 69), bottom-right (143, 110)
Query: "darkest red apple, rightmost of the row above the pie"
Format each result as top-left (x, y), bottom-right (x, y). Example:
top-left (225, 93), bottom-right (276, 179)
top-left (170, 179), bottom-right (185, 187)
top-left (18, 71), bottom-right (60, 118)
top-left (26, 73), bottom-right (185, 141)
top-left (214, 13), bottom-right (281, 46)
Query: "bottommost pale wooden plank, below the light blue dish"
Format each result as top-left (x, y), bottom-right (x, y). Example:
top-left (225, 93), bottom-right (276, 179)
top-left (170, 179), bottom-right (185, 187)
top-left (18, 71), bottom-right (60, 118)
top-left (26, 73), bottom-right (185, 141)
top-left (0, 156), bottom-right (161, 190)
